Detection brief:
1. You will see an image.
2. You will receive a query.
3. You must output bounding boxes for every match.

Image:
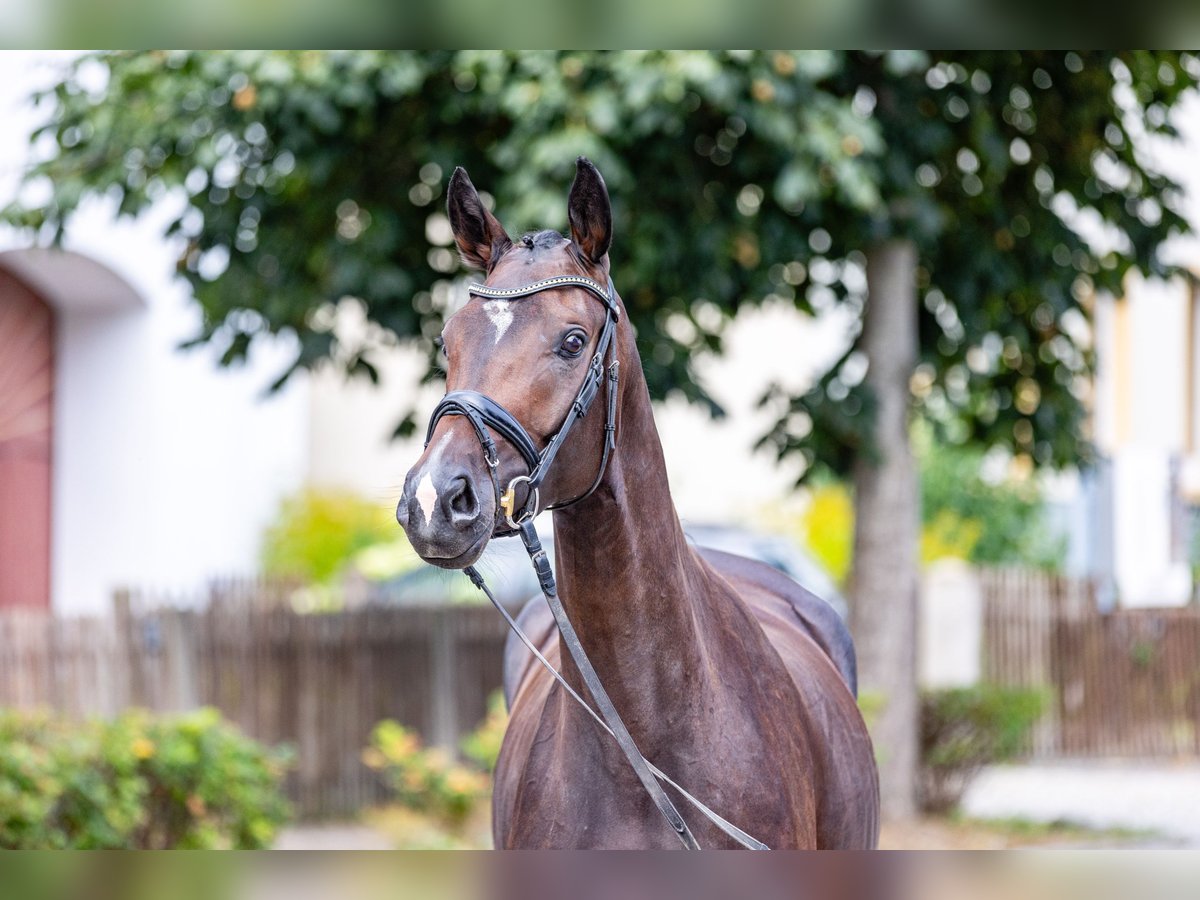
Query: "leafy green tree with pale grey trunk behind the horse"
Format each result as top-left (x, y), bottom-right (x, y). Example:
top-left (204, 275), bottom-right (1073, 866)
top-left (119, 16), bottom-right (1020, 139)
top-left (5, 52), bottom-right (1200, 815)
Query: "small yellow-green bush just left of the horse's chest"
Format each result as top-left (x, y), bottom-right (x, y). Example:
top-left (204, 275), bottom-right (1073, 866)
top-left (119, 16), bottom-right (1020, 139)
top-left (362, 719), bottom-right (490, 823)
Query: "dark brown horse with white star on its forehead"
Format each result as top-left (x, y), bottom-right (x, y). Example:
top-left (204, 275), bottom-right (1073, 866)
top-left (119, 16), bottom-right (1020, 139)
top-left (397, 158), bottom-right (878, 848)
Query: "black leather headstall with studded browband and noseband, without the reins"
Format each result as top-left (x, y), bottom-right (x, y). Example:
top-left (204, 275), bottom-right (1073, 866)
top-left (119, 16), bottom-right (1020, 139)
top-left (425, 275), bottom-right (620, 528)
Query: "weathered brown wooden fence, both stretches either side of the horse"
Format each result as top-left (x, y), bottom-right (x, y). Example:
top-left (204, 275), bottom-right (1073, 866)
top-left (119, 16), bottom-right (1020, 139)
top-left (0, 570), bottom-right (1200, 818)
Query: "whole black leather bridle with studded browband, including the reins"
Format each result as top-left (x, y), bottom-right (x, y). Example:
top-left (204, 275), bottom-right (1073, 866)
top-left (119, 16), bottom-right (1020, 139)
top-left (425, 275), bottom-right (768, 850)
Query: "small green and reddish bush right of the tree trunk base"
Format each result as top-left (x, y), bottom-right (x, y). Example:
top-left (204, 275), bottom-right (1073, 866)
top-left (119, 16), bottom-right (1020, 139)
top-left (920, 685), bottom-right (1044, 812)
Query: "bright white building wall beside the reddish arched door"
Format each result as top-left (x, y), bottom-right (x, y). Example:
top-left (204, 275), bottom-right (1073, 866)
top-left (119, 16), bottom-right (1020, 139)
top-left (0, 54), bottom-right (308, 611)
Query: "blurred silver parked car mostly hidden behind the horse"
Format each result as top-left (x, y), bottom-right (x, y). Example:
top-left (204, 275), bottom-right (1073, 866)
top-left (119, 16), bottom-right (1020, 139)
top-left (368, 516), bottom-right (847, 619)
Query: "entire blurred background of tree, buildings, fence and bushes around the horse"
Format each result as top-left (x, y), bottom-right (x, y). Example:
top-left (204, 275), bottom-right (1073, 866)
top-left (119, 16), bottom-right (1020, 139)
top-left (0, 52), bottom-right (1200, 847)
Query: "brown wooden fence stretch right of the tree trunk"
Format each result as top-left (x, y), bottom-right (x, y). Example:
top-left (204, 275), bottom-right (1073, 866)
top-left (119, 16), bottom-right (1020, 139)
top-left (980, 570), bottom-right (1200, 757)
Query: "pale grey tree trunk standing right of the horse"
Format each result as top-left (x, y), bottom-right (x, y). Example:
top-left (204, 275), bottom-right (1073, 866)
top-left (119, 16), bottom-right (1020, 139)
top-left (851, 240), bottom-right (919, 820)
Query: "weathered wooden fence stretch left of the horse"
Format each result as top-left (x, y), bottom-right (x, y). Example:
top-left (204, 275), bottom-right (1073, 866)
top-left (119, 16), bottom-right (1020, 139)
top-left (0, 582), bottom-right (506, 818)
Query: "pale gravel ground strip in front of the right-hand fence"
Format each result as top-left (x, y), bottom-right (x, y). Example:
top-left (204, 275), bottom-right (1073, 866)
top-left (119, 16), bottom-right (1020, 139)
top-left (962, 760), bottom-right (1200, 847)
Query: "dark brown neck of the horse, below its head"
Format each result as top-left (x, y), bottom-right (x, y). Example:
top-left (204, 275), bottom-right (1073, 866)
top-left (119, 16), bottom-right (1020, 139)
top-left (554, 340), bottom-right (712, 752)
